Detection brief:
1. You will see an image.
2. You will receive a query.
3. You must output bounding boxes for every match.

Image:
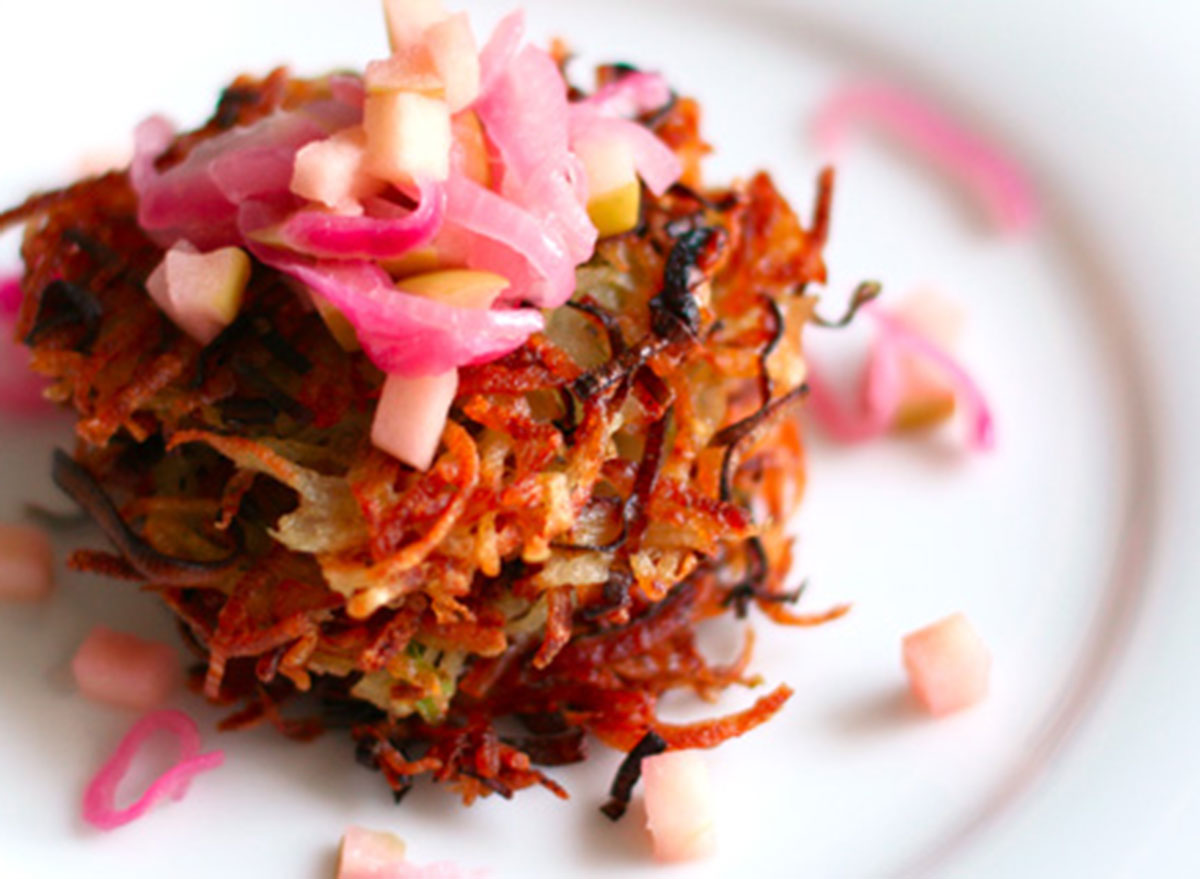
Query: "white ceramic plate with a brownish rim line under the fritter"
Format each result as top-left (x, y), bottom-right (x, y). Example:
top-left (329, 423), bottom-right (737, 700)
top-left (0, 0), bottom-right (1200, 879)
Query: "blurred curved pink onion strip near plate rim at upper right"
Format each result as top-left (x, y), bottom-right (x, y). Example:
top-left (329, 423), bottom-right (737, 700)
top-left (812, 85), bottom-right (1038, 233)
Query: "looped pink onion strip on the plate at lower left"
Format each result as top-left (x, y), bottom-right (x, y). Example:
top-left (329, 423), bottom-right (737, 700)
top-left (83, 711), bottom-right (224, 830)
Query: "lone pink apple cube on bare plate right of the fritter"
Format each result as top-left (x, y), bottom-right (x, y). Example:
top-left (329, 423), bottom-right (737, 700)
top-left (902, 614), bottom-right (991, 717)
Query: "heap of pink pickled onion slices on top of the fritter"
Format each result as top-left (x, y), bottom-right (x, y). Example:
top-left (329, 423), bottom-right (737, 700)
top-left (119, 4), bottom-right (696, 377)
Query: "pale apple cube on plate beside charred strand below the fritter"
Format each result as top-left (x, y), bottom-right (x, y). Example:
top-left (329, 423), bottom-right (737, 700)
top-left (642, 751), bottom-right (716, 862)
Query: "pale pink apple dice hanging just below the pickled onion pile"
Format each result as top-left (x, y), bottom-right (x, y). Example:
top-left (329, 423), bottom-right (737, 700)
top-left (371, 370), bottom-right (458, 471)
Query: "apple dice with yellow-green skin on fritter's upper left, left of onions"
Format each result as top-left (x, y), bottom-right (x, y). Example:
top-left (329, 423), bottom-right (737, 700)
top-left (146, 247), bottom-right (251, 345)
